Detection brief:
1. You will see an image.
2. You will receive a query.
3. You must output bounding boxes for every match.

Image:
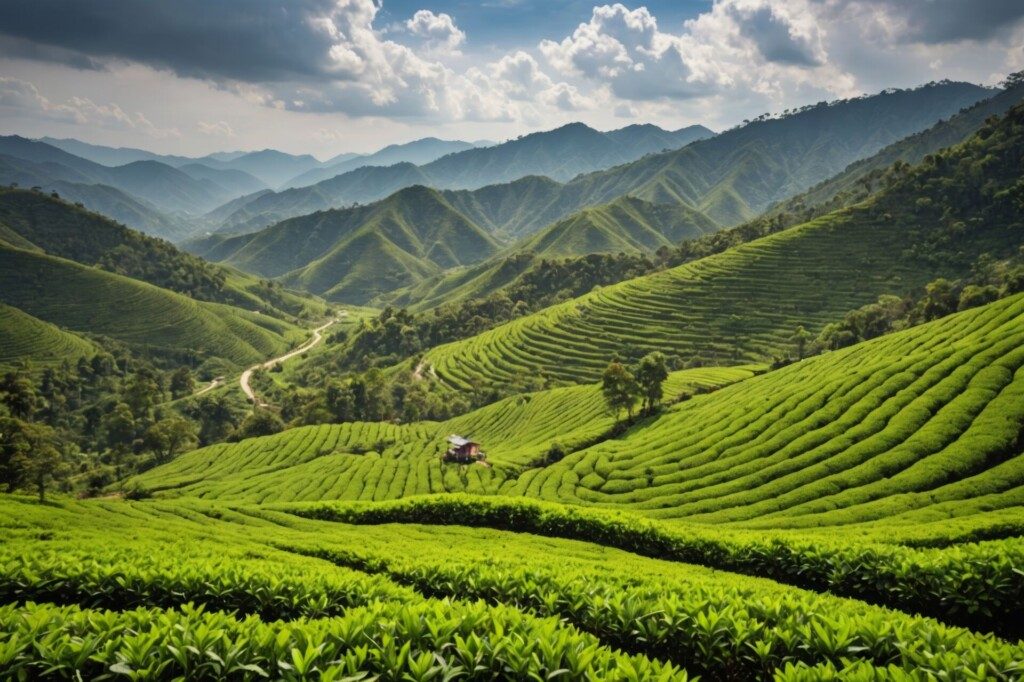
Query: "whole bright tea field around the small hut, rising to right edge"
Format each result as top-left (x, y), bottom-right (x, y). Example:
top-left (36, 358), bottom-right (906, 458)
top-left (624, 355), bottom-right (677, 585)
top-left (138, 295), bottom-right (1024, 544)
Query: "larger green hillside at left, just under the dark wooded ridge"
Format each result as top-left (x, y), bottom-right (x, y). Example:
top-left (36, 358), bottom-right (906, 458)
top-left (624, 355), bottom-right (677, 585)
top-left (0, 240), bottom-right (302, 365)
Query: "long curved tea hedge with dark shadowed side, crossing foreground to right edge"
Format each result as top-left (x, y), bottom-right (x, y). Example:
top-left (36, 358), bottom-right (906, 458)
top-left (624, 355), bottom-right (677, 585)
top-left (285, 496), bottom-right (1024, 637)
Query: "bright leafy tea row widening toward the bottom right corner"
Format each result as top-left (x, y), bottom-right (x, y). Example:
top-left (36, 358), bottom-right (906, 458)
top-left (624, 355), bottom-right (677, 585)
top-left (293, 546), bottom-right (1024, 680)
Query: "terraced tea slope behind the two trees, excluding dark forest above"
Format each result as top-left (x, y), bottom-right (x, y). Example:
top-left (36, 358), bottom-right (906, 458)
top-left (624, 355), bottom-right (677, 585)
top-left (426, 201), bottom-right (1019, 389)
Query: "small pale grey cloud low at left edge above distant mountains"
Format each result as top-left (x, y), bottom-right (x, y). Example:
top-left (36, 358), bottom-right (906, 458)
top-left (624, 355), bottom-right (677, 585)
top-left (0, 77), bottom-right (180, 137)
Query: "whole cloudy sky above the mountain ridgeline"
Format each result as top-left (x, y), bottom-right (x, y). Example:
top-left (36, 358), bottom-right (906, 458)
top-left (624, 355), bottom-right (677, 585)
top-left (0, 0), bottom-right (1024, 159)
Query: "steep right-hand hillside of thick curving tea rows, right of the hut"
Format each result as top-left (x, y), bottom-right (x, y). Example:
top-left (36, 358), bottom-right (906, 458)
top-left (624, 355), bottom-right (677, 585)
top-left (524, 295), bottom-right (1024, 528)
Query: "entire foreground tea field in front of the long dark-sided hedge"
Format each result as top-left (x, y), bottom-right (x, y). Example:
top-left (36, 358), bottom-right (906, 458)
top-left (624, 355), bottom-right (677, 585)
top-left (0, 498), bottom-right (1024, 680)
